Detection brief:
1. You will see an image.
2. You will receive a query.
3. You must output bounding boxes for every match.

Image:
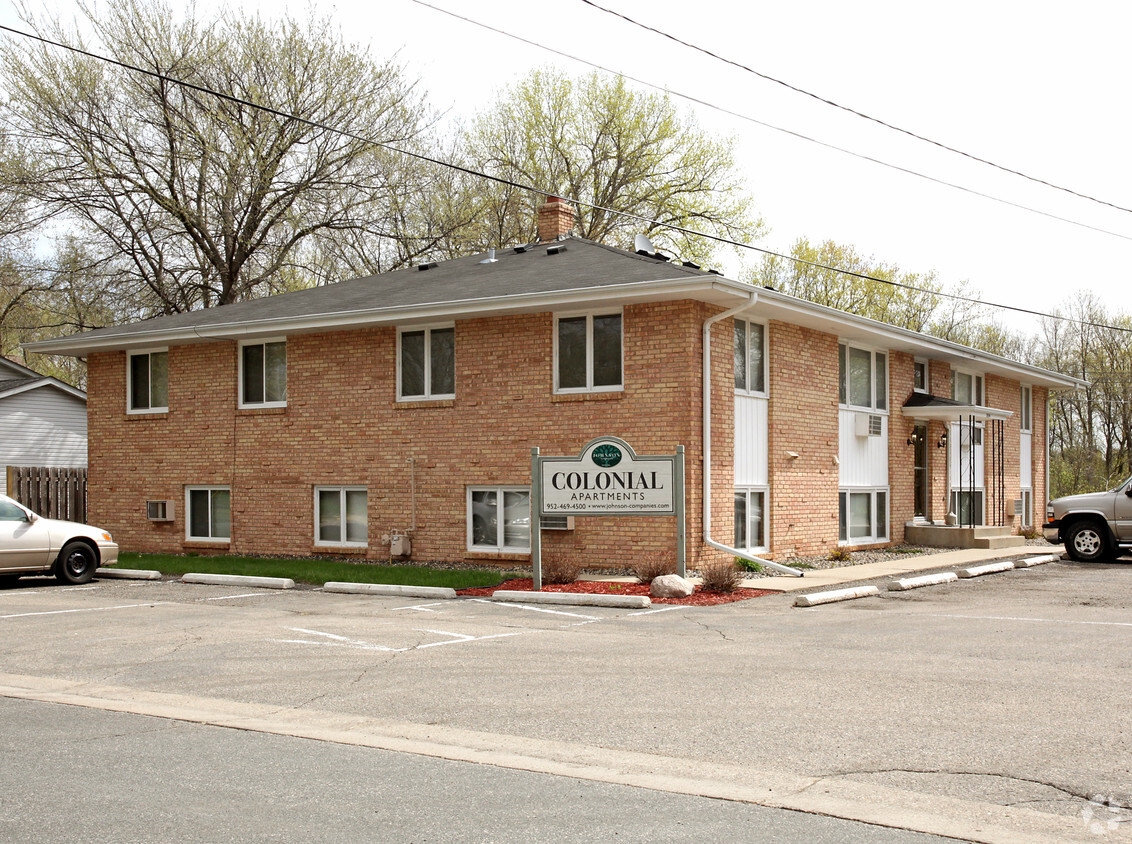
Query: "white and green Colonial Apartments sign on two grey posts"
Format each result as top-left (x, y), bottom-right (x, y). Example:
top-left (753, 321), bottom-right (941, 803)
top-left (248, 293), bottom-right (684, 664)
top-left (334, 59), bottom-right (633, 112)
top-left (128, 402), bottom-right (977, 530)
top-left (531, 437), bottom-right (685, 589)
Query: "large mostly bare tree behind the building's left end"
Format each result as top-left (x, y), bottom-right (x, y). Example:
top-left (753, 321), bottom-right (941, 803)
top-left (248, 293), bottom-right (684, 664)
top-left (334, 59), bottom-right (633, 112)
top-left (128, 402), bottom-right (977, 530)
top-left (2, 0), bottom-right (446, 317)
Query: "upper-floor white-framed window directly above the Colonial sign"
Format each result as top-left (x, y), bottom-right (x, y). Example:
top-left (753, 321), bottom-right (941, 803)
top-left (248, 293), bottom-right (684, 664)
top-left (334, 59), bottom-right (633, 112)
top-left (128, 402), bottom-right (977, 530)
top-left (555, 313), bottom-right (623, 393)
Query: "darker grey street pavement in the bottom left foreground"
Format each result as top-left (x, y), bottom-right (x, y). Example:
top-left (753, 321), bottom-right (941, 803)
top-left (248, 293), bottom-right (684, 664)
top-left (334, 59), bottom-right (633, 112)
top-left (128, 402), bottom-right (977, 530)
top-left (0, 699), bottom-right (951, 844)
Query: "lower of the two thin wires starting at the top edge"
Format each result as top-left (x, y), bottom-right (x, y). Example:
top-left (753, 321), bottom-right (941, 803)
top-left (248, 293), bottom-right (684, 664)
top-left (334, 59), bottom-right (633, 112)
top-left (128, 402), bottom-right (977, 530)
top-left (410, 0), bottom-right (1132, 241)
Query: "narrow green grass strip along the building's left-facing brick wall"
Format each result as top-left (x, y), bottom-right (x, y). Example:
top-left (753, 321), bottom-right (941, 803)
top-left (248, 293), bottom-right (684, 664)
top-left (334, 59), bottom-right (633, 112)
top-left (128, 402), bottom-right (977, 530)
top-left (118, 553), bottom-right (506, 589)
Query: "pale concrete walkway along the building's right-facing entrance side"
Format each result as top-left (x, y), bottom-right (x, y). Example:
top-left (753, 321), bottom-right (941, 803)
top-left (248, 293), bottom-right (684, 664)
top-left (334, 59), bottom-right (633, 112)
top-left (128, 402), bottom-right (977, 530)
top-left (581, 545), bottom-right (1064, 592)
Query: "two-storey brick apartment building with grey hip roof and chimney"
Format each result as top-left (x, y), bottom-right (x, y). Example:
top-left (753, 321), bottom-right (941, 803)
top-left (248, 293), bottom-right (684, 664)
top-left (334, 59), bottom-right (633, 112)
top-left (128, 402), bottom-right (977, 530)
top-left (22, 196), bottom-right (1077, 568)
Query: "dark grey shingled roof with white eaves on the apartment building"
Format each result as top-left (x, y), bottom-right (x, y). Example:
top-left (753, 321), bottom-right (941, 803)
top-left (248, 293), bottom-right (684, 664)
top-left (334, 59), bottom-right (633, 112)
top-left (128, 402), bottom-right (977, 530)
top-left (17, 236), bottom-right (1081, 389)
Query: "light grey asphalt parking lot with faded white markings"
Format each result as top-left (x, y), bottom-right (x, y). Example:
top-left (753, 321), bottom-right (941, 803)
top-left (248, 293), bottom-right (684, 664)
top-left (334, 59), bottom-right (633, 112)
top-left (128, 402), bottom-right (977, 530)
top-left (0, 562), bottom-right (1132, 841)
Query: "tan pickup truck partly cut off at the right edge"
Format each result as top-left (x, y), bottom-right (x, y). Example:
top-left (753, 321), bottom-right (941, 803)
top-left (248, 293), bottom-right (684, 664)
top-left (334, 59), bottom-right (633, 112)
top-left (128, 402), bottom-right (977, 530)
top-left (1041, 477), bottom-right (1132, 562)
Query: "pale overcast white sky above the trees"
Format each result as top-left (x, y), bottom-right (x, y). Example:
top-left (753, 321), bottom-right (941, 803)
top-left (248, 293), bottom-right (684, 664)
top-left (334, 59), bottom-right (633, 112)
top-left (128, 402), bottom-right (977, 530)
top-left (0, 0), bottom-right (1132, 330)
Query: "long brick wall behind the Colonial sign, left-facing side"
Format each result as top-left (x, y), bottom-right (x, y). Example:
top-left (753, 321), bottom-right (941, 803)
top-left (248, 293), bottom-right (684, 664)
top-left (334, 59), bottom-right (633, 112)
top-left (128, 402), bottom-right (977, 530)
top-left (88, 302), bottom-right (734, 566)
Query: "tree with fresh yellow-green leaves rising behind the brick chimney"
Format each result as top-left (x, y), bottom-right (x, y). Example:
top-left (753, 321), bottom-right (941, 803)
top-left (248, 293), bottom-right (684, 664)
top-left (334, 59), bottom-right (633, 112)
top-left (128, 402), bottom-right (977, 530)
top-left (448, 68), bottom-right (763, 264)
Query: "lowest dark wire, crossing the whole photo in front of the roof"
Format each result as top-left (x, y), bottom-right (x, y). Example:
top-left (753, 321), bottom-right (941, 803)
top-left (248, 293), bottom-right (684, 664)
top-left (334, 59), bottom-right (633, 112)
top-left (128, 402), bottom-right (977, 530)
top-left (0, 21), bottom-right (1132, 334)
